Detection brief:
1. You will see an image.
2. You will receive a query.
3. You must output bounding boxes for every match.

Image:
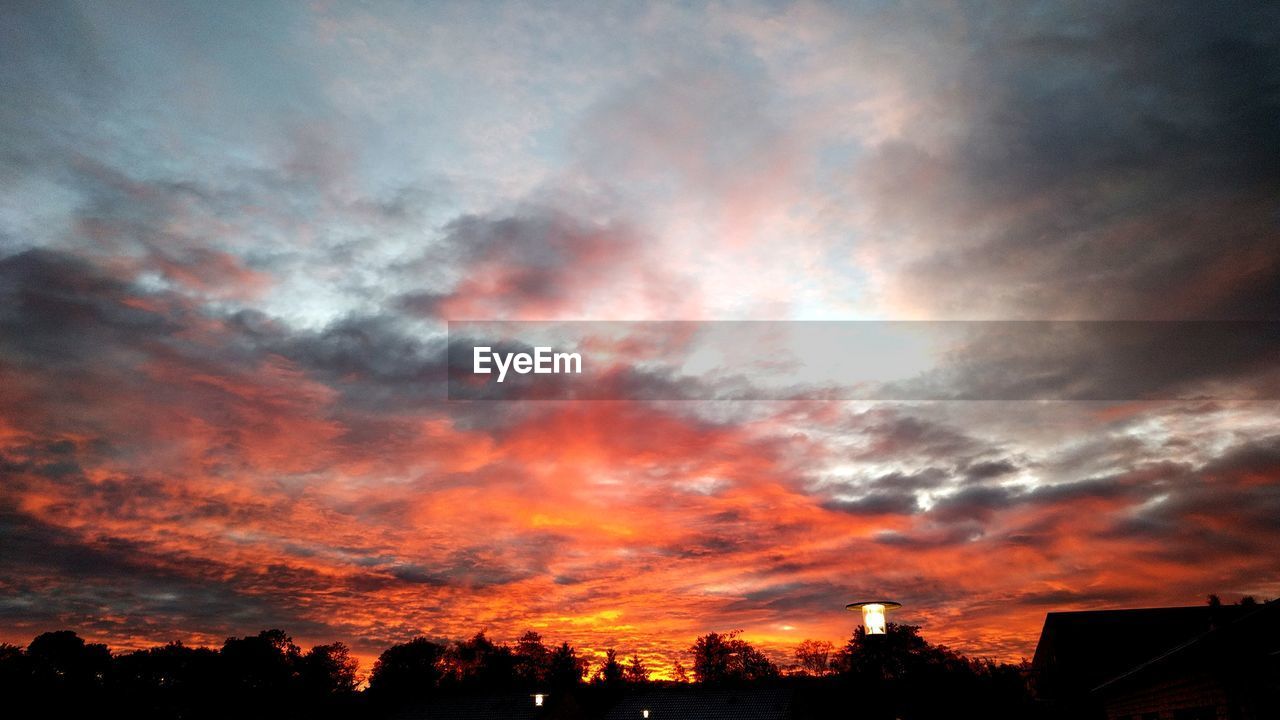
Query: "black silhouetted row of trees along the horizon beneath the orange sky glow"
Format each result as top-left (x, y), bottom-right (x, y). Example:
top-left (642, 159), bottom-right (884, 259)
top-left (0, 624), bottom-right (1029, 719)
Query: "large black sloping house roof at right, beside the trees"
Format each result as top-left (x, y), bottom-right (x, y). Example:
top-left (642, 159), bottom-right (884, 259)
top-left (1032, 605), bottom-right (1252, 697)
